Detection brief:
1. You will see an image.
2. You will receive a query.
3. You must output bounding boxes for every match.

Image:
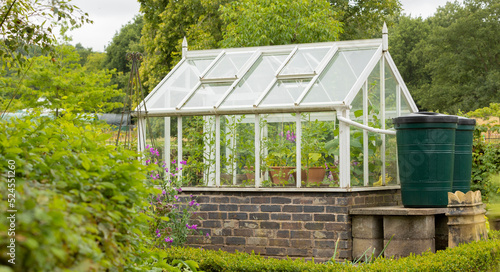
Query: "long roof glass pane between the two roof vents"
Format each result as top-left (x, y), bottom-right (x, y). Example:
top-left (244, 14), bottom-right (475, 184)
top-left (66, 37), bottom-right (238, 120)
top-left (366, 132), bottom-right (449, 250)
top-left (221, 55), bottom-right (287, 108)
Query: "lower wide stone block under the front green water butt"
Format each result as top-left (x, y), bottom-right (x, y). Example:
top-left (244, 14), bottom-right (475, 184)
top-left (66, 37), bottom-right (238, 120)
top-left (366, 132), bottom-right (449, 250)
top-left (384, 238), bottom-right (436, 258)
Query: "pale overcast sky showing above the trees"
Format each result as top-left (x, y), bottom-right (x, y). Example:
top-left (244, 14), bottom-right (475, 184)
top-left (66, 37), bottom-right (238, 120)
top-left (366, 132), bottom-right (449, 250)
top-left (70, 0), bottom-right (456, 52)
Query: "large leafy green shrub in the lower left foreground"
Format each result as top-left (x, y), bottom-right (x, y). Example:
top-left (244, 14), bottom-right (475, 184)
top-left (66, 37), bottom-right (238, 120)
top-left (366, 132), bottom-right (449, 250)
top-left (0, 115), bottom-right (153, 271)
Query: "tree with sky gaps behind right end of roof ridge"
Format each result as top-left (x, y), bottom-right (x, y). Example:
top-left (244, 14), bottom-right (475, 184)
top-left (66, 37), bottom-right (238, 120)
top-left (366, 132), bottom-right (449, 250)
top-left (330, 0), bottom-right (401, 40)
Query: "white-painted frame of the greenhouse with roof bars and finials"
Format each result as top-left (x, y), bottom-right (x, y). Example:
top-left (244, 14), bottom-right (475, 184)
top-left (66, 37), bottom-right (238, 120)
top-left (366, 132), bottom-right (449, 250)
top-left (135, 25), bottom-right (418, 190)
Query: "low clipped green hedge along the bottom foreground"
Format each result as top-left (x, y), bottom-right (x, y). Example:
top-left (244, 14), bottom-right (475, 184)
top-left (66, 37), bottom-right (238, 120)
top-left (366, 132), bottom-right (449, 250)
top-left (152, 232), bottom-right (500, 272)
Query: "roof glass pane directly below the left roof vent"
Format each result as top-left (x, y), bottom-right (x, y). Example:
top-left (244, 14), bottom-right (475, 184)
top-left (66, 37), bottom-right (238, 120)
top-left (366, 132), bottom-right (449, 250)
top-left (182, 83), bottom-right (231, 109)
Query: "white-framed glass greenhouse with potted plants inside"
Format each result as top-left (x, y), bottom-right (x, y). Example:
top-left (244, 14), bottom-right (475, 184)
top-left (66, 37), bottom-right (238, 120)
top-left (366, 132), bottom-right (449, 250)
top-left (136, 28), bottom-right (418, 190)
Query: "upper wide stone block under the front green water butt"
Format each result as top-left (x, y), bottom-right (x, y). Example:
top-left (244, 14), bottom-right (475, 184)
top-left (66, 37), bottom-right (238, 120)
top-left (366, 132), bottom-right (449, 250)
top-left (384, 215), bottom-right (435, 240)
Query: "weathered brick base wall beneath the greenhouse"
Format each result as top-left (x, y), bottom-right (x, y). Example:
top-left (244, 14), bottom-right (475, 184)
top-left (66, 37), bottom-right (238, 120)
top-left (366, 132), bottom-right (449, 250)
top-left (184, 188), bottom-right (401, 262)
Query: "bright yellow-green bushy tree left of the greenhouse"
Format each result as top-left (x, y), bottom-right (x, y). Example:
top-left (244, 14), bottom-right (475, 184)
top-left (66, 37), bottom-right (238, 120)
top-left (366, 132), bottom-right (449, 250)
top-left (2, 46), bottom-right (121, 116)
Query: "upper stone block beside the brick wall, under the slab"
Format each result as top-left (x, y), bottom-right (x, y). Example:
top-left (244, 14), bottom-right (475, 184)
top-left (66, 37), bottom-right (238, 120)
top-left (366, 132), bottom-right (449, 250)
top-left (352, 215), bottom-right (384, 239)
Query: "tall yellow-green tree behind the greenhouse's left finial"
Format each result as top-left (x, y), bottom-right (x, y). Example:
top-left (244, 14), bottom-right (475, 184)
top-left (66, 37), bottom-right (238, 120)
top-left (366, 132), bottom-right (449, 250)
top-left (139, 0), bottom-right (232, 89)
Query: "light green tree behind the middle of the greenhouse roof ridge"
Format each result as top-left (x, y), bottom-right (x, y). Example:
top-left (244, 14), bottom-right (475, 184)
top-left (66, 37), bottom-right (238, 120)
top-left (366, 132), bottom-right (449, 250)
top-left (220, 0), bottom-right (342, 47)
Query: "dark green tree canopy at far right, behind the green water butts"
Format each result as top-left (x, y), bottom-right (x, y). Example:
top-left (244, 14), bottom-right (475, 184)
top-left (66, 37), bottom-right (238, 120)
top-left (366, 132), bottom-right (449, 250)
top-left (389, 0), bottom-right (500, 113)
